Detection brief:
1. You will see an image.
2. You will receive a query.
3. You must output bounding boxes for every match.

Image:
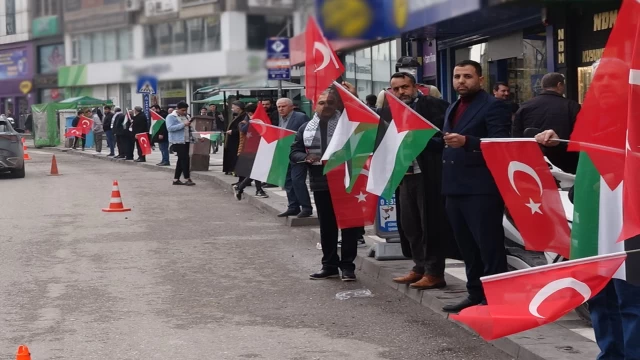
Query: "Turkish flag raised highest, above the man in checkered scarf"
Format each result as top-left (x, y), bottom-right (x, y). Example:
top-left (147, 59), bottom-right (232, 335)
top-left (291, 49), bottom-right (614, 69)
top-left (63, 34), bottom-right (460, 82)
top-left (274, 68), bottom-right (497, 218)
top-left (304, 16), bottom-right (344, 104)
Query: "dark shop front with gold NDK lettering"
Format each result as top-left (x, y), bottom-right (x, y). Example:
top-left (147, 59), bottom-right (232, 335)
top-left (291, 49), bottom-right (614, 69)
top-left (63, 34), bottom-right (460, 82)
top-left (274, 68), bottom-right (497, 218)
top-left (549, 0), bottom-right (622, 103)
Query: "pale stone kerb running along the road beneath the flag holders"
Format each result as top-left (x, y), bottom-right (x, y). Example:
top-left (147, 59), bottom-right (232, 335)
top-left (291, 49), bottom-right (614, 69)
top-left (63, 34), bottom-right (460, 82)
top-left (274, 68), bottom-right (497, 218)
top-left (42, 148), bottom-right (600, 360)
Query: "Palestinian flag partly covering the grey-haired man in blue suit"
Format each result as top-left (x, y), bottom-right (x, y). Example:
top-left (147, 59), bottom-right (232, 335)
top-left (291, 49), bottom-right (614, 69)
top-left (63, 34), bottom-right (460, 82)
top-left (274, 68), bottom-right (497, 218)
top-left (235, 120), bottom-right (296, 187)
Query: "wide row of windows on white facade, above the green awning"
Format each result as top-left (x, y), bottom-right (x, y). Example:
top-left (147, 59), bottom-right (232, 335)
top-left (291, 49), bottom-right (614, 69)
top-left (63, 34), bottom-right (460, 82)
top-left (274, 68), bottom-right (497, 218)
top-left (144, 16), bottom-right (221, 57)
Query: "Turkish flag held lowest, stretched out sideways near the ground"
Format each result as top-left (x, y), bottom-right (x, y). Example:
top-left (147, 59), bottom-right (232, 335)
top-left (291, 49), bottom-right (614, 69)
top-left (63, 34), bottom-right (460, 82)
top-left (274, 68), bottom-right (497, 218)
top-left (450, 252), bottom-right (627, 340)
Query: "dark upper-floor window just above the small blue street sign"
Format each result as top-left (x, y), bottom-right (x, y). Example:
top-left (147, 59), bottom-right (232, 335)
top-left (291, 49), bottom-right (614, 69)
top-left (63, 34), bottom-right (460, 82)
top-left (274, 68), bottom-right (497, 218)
top-left (247, 15), bottom-right (293, 50)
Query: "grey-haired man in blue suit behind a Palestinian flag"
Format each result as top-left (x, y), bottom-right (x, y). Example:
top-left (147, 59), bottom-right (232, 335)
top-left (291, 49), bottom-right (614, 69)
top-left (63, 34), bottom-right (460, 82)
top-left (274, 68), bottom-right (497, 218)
top-left (276, 98), bottom-right (313, 218)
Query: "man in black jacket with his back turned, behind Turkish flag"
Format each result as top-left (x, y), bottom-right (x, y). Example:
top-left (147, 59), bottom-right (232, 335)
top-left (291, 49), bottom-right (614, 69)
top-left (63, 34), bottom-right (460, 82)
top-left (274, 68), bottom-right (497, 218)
top-left (511, 73), bottom-right (580, 174)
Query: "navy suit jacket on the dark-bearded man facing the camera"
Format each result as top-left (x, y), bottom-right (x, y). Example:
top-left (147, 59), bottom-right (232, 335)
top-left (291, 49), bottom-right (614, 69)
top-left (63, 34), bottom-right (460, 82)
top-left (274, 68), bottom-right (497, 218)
top-left (433, 91), bottom-right (511, 195)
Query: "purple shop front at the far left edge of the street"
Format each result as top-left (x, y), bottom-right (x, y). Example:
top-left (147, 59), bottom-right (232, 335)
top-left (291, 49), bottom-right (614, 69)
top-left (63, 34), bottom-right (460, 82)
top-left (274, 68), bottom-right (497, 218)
top-left (0, 42), bottom-right (35, 127)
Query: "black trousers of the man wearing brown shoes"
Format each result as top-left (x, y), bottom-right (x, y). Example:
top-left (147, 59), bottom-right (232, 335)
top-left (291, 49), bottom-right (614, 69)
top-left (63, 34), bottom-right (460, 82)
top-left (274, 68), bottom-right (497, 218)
top-left (398, 174), bottom-right (445, 277)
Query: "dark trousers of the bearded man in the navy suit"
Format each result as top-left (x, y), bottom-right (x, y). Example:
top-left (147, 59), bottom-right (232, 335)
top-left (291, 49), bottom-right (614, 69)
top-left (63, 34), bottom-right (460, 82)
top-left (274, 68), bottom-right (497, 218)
top-left (446, 195), bottom-right (507, 302)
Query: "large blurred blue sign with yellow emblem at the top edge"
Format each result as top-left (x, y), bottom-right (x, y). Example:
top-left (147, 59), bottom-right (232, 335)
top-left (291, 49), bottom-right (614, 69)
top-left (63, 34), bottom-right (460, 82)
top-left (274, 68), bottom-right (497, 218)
top-left (316, 0), bottom-right (481, 39)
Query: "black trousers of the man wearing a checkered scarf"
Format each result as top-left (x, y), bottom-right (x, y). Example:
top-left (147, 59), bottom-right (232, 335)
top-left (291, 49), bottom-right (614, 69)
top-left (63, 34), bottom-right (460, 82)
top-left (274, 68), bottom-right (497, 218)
top-left (313, 191), bottom-right (363, 271)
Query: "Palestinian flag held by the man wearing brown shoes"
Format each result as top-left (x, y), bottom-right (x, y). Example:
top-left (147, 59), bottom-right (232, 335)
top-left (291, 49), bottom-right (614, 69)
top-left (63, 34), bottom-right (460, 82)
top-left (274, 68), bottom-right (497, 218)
top-left (367, 92), bottom-right (440, 199)
